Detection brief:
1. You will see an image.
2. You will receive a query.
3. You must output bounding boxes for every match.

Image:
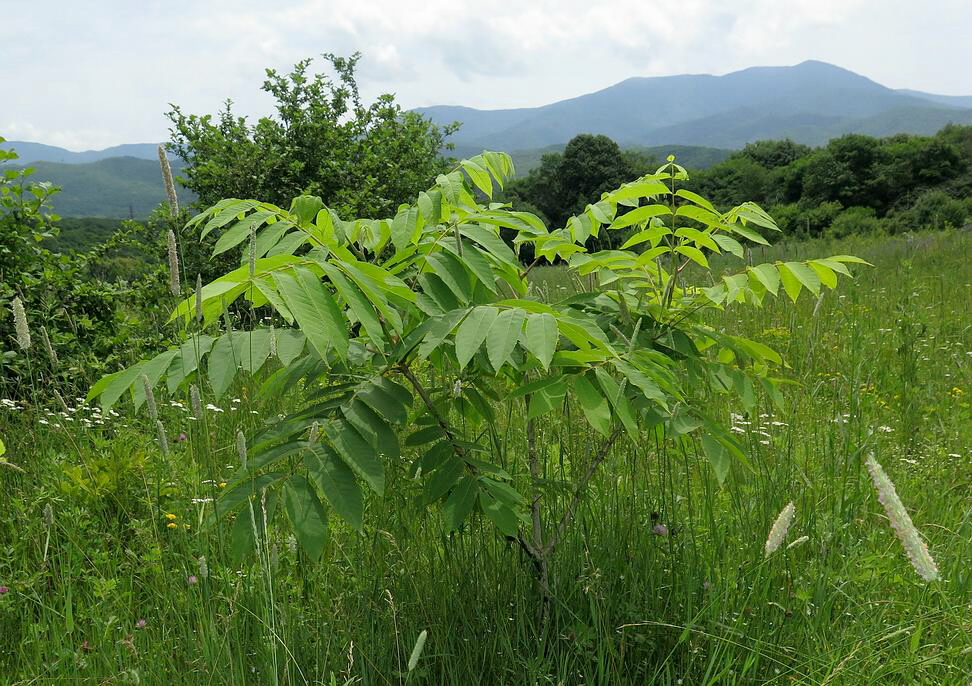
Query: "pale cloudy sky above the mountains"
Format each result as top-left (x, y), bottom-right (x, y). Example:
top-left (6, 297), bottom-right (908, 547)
top-left (0, 0), bottom-right (972, 150)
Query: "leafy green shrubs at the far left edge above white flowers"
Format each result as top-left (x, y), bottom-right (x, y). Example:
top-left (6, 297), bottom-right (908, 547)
top-left (0, 139), bottom-right (175, 398)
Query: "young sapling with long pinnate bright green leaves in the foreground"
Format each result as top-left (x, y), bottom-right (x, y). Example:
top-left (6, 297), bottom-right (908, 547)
top-left (89, 152), bottom-right (861, 575)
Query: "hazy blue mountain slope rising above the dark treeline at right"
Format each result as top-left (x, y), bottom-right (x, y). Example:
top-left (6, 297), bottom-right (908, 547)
top-left (416, 61), bottom-right (972, 151)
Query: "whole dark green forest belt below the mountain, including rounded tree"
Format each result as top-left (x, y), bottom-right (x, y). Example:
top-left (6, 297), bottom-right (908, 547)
top-left (509, 126), bottom-right (972, 245)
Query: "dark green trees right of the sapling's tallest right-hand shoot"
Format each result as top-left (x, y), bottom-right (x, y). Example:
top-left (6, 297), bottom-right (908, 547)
top-left (693, 126), bottom-right (972, 236)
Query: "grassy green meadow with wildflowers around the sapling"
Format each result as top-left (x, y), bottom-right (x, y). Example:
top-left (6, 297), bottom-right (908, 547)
top-left (0, 231), bottom-right (972, 686)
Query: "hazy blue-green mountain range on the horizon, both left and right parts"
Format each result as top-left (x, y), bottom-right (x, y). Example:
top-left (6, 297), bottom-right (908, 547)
top-left (0, 60), bottom-right (972, 217)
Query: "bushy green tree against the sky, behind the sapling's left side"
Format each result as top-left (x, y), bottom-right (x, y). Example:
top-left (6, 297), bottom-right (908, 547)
top-left (167, 53), bottom-right (456, 217)
